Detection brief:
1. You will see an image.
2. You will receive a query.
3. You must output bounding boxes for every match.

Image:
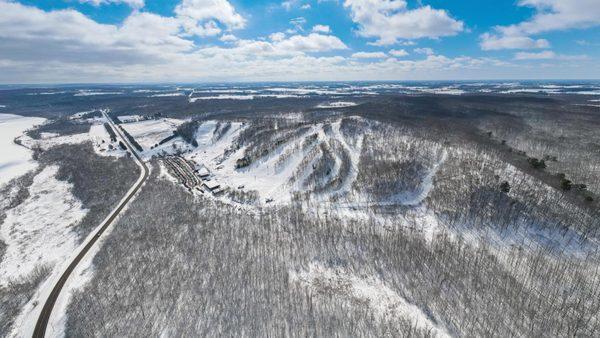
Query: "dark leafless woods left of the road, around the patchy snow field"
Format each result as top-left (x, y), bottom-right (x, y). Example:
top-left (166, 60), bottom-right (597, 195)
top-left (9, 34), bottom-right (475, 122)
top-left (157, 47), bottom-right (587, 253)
top-left (0, 139), bottom-right (138, 336)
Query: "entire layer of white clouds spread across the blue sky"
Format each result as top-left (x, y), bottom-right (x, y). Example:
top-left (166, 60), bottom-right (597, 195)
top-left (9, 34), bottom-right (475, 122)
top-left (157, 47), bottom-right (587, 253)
top-left (0, 0), bottom-right (597, 83)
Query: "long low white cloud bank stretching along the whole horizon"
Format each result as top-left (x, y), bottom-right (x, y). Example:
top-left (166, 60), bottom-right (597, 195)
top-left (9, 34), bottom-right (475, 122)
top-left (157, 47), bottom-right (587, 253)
top-left (0, 0), bottom-right (600, 83)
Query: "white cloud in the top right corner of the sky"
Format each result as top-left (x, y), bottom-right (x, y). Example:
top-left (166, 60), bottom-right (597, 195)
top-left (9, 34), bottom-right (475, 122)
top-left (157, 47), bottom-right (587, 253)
top-left (481, 0), bottom-right (600, 50)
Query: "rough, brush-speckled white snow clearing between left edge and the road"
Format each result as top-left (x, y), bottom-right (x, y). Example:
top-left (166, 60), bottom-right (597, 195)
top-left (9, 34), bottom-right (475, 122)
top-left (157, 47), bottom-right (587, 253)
top-left (0, 166), bottom-right (87, 285)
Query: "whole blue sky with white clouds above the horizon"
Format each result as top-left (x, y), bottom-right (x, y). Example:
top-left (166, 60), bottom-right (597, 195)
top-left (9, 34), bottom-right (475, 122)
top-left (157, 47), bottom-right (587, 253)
top-left (0, 0), bottom-right (600, 84)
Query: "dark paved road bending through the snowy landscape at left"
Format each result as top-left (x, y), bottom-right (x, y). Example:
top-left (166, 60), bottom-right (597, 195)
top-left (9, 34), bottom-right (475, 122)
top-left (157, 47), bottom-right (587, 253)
top-left (33, 112), bottom-right (149, 338)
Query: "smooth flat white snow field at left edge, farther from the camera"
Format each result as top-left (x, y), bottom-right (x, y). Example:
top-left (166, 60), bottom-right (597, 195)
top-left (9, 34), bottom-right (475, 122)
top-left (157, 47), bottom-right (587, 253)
top-left (0, 114), bottom-right (46, 186)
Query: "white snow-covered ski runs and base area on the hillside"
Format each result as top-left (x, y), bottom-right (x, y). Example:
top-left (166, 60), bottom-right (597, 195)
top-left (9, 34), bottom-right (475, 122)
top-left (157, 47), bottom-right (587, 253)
top-left (131, 115), bottom-right (445, 209)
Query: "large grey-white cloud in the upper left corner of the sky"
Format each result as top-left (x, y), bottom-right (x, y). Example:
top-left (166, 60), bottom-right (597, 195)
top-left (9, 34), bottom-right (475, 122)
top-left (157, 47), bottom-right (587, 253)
top-left (0, 0), bottom-right (194, 64)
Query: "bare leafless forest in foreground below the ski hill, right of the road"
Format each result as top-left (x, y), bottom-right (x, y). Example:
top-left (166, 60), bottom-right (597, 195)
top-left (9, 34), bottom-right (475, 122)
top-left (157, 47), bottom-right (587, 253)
top-left (67, 164), bottom-right (600, 337)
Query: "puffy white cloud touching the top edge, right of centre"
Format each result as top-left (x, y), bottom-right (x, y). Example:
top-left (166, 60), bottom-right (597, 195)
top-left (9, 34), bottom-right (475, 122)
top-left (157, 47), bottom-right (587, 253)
top-left (344, 0), bottom-right (464, 45)
